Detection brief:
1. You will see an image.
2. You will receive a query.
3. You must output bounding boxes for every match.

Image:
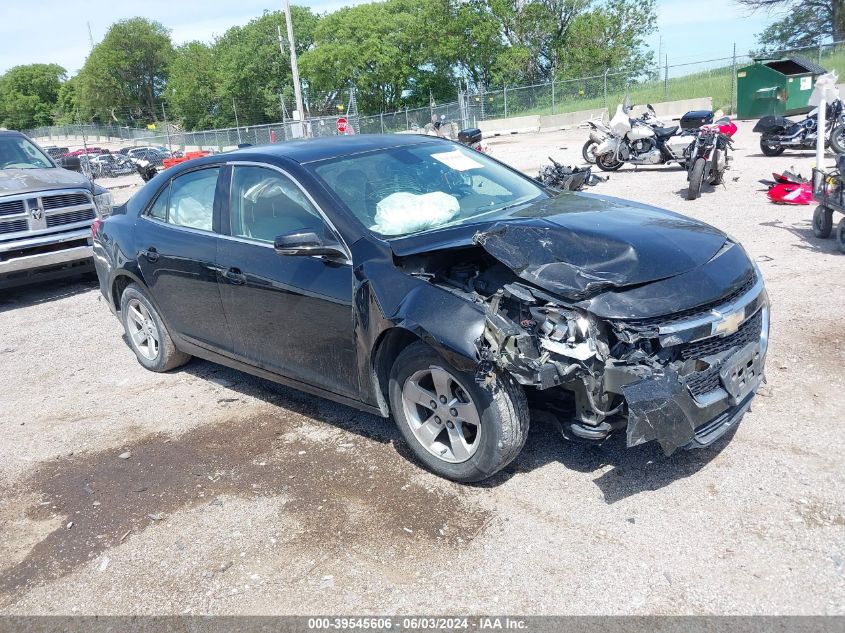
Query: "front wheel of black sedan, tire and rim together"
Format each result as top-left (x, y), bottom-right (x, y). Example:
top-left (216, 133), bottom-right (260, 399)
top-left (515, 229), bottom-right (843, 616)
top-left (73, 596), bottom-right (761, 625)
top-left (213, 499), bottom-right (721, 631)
top-left (388, 342), bottom-right (529, 483)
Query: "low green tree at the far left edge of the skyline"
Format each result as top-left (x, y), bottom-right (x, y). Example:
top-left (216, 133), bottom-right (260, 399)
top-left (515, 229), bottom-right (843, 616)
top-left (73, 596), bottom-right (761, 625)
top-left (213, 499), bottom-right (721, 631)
top-left (0, 64), bottom-right (67, 130)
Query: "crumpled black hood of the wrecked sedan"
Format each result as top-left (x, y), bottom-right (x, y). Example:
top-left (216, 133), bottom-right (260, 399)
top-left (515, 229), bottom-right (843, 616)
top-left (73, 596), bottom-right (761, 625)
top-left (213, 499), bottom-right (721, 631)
top-left (474, 194), bottom-right (727, 300)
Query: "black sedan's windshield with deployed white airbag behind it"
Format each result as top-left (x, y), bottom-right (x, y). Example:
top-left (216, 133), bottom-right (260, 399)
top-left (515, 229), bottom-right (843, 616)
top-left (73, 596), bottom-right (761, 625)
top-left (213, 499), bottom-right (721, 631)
top-left (313, 143), bottom-right (547, 237)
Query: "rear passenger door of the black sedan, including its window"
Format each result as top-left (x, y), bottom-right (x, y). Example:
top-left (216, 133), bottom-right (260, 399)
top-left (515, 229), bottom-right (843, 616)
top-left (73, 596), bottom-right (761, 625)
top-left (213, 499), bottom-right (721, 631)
top-left (136, 165), bottom-right (232, 354)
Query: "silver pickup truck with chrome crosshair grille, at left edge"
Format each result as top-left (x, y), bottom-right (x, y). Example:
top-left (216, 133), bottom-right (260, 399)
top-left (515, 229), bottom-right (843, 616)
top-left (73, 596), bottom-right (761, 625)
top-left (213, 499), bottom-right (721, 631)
top-left (0, 131), bottom-right (112, 288)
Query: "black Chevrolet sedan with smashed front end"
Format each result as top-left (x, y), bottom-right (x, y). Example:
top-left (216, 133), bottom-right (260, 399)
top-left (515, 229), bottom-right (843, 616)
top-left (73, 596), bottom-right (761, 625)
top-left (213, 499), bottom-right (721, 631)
top-left (94, 135), bottom-right (769, 481)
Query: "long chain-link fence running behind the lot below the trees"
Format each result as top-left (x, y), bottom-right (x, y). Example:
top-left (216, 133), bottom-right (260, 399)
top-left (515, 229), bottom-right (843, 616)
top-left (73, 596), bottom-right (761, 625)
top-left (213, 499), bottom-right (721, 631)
top-left (27, 42), bottom-right (845, 151)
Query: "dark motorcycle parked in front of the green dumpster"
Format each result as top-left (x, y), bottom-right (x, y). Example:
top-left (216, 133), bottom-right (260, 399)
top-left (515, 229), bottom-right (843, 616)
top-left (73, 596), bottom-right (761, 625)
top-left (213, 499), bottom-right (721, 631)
top-left (753, 99), bottom-right (845, 156)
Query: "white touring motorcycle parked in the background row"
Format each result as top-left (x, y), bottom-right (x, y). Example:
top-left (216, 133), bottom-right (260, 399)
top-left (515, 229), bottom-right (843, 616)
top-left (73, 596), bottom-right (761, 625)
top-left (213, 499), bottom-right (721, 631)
top-left (596, 102), bottom-right (695, 171)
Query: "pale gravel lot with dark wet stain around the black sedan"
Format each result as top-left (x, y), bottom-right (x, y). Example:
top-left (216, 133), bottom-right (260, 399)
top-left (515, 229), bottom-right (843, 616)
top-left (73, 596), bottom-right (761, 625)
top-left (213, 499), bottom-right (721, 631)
top-left (0, 123), bottom-right (845, 614)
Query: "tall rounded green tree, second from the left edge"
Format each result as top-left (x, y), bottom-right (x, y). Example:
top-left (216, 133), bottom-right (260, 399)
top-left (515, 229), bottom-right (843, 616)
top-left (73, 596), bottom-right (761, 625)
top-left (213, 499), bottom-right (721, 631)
top-left (77, 18), bottom-right (173, 123)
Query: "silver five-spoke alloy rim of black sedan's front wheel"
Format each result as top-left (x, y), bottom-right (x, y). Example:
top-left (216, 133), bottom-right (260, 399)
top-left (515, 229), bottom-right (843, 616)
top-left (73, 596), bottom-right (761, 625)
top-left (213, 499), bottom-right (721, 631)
top-left (402, 365), bottom-right (481, 464)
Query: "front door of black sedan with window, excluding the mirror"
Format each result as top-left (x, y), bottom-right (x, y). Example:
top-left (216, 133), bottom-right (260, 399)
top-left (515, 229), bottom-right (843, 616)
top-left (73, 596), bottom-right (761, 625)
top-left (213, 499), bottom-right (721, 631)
top-left (218, 164), bottom-right (360, 398)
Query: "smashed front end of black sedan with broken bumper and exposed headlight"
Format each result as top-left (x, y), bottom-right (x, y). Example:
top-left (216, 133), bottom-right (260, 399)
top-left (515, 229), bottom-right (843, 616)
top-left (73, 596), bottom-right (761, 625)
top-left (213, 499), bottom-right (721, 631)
top-left (479, 271), bottom-right (769, 455)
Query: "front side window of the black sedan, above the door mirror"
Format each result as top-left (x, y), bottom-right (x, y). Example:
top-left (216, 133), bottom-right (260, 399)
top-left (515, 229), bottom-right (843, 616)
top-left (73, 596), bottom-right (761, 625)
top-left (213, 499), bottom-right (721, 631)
top-left (230, 165), bottom-right (326, 244)
